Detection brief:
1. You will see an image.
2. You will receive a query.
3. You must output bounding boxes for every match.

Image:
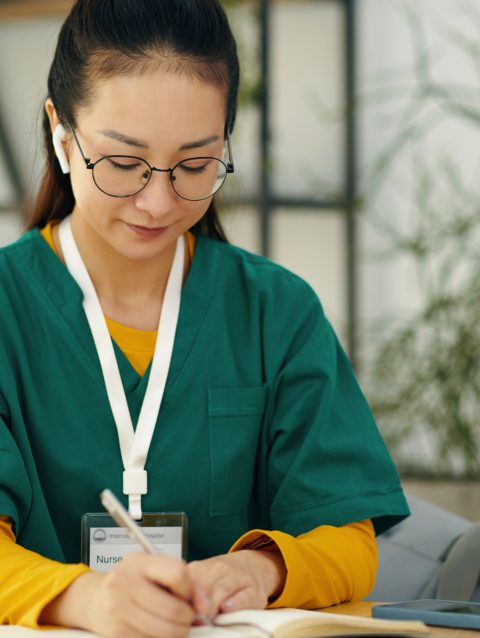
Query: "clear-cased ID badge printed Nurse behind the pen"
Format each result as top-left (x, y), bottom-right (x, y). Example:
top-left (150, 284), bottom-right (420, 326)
top-left (81, 512), bottom-right (187, 572)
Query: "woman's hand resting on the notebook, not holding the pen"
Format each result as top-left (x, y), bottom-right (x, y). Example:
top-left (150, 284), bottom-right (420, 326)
top-left (187, 550), bottom-right (286, 618)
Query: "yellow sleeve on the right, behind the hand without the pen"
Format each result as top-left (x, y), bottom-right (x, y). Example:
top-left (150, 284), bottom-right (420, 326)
top-left (230, 520), bottom-right (378, 609)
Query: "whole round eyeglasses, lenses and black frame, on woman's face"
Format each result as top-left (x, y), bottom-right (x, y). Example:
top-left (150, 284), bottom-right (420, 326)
top-left (70, 126), bottom-right (234, 202)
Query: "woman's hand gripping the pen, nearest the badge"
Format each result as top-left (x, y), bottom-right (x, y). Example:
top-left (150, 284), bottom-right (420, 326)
top-left (41, 553), bottom-right (195, 638)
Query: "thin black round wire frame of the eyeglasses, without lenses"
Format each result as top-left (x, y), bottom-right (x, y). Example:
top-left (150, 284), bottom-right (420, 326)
top-left (69, 125), bottom-right (235, 202)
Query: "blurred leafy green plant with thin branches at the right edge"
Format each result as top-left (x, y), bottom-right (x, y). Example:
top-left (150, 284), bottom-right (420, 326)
top-left (363, 0), bottom-right (480, 477)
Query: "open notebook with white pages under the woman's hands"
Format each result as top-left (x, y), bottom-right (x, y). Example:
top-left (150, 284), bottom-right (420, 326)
top-left (0, 609), bottom-right (429, 638)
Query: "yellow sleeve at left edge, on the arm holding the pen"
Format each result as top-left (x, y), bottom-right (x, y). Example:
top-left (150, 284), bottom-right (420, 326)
top-left (0, 516), bottom-right (89, 628)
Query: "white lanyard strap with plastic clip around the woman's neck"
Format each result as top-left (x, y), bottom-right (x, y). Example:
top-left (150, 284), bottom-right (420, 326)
top-left (59, 216), bottom-right (185, 520)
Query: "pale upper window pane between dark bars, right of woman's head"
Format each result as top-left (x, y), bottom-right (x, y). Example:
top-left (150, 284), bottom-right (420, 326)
top-left (271, 1), bottom-right (344, 198)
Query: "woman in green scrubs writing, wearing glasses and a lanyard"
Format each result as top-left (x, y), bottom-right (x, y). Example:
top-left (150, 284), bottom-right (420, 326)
top-left (0, 0), bottom-right (408, 638)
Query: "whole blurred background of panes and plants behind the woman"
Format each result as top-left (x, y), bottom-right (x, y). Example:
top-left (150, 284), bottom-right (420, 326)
top-left (0, 0), bottom-right (480, 518)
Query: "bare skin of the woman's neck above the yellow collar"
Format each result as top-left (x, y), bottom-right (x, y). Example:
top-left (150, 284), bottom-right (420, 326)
top-left (54, 213), bottom-right (180, 330)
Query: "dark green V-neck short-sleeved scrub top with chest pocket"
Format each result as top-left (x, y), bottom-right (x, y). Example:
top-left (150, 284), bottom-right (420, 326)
top-left (0, 230), bottom-right (408, 562)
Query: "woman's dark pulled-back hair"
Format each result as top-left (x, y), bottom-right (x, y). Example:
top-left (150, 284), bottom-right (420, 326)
top-left (27, 0), bottom-right (239, 241)
